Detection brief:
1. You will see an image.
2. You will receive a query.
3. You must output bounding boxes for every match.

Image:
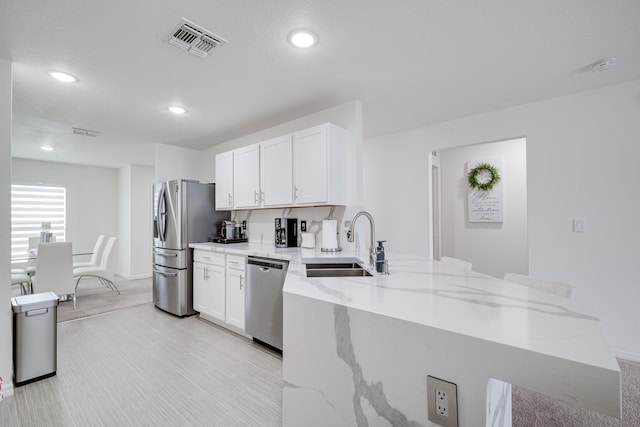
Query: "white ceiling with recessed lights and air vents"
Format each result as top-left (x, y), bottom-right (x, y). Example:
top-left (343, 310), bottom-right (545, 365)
top-left (0, 0), bottom-right (640, 167)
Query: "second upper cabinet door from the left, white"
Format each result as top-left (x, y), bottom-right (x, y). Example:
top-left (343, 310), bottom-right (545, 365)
top-left (233, 144), bottom-right (260, 208)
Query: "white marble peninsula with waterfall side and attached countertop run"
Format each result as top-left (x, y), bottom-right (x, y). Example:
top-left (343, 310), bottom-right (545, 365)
top-left (192, 244), bottom-right (620, 426)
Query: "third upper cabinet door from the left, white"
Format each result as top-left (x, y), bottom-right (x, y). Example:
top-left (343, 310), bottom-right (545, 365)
top-left (260, 135), bottom-right (293, 206)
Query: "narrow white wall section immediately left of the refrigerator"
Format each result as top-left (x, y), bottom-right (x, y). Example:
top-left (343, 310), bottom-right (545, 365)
top-left (117, 165), bottom-right (155, 279)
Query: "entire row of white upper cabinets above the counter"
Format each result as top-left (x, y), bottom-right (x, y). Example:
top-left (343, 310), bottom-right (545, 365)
top-left (216, 123), bottom-right (347, 209)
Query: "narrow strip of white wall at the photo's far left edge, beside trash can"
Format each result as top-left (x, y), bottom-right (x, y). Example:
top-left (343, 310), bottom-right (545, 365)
top-left (0, 59), bottom-right (13, 404)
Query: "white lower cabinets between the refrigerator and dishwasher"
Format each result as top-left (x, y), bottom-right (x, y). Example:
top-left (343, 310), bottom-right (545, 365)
top-left (193, 249), bottom-right (246, 332)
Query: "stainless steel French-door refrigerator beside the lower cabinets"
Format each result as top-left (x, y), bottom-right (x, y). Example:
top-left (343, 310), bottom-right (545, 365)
top-left (153, 179), bottom-right (229, 317)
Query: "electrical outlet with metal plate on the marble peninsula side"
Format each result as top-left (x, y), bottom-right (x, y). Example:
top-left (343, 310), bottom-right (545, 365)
top-left (427, 375), bottom-right (458, 427)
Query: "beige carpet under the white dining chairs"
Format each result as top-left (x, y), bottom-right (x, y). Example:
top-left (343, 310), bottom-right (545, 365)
top-left (58, 277), bottom-right (153, 322)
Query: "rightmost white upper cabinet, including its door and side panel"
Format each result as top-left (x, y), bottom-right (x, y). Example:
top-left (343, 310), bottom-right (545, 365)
top-left (293, 123), bottom-right (346, 205)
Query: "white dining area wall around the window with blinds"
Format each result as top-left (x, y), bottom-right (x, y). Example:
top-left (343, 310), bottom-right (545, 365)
top-left (12, 158), bottom-right (118, 266)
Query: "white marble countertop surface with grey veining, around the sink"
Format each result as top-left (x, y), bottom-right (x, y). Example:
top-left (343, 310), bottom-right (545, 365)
top-left (190, 243), bottom-right (619, 371)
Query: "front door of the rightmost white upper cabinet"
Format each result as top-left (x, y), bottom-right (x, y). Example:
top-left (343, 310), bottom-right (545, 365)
top-left (293, 125), bottom-right (328, 204)
